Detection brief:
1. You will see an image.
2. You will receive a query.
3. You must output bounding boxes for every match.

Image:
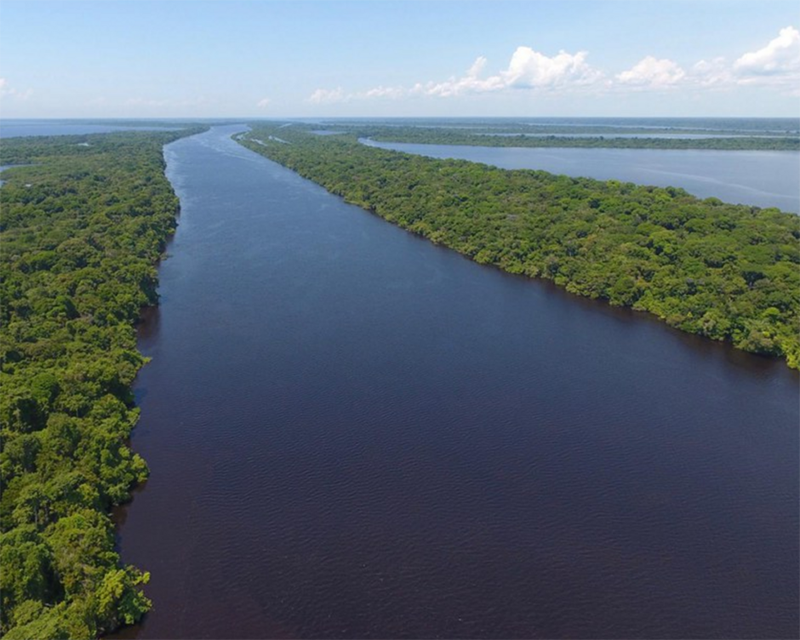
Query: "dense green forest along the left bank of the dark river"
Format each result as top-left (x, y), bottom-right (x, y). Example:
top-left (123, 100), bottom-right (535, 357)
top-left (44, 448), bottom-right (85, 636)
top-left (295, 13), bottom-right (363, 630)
top-left (0, 130), bottom-right (200, 640)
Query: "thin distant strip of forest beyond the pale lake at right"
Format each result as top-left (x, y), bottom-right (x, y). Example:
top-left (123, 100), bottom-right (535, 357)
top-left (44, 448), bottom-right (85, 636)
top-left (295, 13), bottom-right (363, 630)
top-left (342, 125), bottom-right (800, 151)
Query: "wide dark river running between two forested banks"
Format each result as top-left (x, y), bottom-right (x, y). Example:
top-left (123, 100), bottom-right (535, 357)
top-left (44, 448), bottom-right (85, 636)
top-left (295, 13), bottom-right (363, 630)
top-left (114, 127), bottom-right (800, 640)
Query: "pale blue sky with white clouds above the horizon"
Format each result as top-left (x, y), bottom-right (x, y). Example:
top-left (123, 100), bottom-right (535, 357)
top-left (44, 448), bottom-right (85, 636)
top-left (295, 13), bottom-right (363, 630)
top-left (0, 0), bottom-right (800, 118)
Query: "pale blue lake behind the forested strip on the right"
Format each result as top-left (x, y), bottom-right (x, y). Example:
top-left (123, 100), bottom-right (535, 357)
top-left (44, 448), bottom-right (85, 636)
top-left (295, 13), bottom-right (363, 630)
top-left (362, 140), bottom-right (800, 213)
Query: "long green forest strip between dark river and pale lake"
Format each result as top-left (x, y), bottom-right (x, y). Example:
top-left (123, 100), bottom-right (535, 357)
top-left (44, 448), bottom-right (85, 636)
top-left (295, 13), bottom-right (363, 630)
top-left (241, 125), bottom-right (800, 368)
